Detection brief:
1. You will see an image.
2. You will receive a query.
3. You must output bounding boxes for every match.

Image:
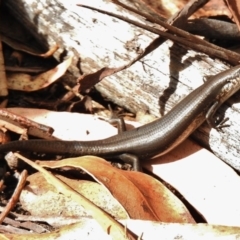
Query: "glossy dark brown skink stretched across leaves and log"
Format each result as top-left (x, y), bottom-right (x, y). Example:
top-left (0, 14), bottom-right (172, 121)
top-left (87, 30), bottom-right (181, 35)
top-left (0, 65), bottom-right (240, 170)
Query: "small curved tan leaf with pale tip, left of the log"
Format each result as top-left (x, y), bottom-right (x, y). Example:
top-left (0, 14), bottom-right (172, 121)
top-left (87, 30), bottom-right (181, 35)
top-left (7, 57), bottom-right (72, 92)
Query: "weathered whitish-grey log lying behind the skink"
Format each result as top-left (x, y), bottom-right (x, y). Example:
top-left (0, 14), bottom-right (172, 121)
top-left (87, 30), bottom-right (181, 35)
top-left (4, 0), bottom-right (240, 170)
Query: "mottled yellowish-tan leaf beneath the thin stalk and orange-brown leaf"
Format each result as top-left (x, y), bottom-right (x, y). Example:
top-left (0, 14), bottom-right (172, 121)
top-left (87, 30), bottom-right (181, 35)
top-left (20, 172), bottom-right (128, 222)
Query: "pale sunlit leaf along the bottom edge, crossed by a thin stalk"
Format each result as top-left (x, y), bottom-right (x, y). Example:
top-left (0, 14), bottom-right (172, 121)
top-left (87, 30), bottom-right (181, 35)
top-left (0, 219), bottom-right (240, 240)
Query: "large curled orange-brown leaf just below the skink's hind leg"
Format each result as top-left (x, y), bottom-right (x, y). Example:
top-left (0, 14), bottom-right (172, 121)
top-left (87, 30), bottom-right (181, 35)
top-left (39, 156), bottom-right (194, 223)
